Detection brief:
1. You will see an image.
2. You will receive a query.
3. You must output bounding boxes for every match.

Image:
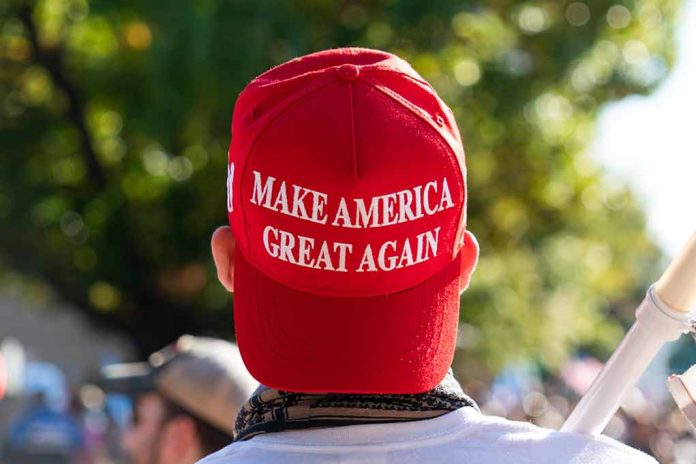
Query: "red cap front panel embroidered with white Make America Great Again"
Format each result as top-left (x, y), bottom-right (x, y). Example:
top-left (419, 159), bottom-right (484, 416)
top-left (233, 79), bottom-right (464, 296)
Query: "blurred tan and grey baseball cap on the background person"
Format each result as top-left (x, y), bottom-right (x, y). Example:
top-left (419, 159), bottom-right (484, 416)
top-left (102, 335), bottom-right (258, 436)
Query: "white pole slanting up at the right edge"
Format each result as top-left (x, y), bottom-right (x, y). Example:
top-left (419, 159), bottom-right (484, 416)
top-left (561, 234), bottom-right (696, 435)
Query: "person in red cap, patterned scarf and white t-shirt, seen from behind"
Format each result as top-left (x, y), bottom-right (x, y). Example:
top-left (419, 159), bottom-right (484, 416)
top-left (202, 48), bottom-right (655, 464)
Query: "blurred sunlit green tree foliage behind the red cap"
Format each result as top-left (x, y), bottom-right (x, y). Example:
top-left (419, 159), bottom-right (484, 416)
top-left (0, 0), bottom-right (679, 373)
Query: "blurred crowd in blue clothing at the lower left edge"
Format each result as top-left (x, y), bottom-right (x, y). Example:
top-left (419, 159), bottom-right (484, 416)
top-left (0, 354), bottom-right (132, 464)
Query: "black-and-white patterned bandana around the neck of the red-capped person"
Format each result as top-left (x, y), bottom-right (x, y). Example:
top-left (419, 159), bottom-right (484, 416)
top-left (234, 369), bottom-right (478, 441)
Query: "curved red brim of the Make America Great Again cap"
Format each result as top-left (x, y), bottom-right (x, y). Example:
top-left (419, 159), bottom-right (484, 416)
top-left (234, 251), bottom-right (466, 394)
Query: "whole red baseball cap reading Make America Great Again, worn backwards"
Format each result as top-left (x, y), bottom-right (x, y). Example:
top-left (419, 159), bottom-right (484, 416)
top-left (227, 48), bottom-right (478, 393)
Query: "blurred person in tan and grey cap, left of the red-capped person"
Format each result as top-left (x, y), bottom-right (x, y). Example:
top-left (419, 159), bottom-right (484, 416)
top-left (103, 335), bottom-right (256, 464)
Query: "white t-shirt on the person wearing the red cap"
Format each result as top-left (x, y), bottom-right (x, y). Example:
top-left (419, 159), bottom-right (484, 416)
top-left (198, 408), bottom-right (656, 464)
